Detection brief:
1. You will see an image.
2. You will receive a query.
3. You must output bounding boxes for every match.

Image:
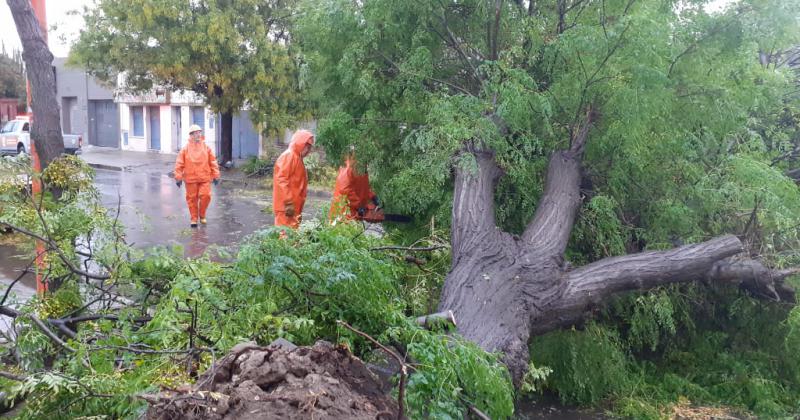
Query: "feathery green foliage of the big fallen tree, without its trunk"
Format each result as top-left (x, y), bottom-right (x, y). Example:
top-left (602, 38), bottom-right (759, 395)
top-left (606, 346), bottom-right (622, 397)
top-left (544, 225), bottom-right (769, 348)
top-left (297, 0), bottom-right (800, 257)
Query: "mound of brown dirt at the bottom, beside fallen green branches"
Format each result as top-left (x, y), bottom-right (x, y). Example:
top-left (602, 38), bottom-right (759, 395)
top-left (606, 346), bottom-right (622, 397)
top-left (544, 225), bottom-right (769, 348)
top-left (143, 341), bottom-right (397, 420)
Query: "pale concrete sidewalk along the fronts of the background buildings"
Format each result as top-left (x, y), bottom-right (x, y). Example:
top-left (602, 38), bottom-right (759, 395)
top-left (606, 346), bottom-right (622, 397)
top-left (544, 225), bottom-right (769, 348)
top-left (79, 145), bottom-right (247, 182)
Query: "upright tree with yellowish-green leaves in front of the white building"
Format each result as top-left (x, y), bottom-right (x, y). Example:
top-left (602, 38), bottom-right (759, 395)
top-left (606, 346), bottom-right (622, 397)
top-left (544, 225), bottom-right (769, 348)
top-left (70, 0), bottom-right (303, 162)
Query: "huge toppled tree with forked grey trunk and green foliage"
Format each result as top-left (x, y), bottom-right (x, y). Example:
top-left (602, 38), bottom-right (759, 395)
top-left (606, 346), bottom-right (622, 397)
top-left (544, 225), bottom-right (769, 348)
top-left (297, 0), bottom-right (800, 383)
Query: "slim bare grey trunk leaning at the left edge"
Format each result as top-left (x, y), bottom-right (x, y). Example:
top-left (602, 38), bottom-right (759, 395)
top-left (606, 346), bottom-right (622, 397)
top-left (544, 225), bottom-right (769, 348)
top-left (7, 0), bottom-right (64, 169)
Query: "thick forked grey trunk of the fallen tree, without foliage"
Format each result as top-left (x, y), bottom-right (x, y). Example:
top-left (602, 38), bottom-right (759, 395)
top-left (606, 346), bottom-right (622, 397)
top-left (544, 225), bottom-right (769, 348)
top-left (439, 116), bottom-right (797, 384)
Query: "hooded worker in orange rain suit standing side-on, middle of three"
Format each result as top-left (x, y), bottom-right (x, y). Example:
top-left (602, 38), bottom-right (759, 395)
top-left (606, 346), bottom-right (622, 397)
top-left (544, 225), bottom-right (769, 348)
top-left (272, 130), bottom-right (314, 229)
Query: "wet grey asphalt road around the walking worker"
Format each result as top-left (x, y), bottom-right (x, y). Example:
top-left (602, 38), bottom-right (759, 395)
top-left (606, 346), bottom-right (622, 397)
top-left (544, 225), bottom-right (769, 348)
top-left (0, 169), bottom-right (330, 299)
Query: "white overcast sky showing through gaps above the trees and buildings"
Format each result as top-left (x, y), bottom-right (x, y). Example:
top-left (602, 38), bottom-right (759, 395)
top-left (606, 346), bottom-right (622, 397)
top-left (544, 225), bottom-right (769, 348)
top-left (0, 0), bottom-right (733, 57)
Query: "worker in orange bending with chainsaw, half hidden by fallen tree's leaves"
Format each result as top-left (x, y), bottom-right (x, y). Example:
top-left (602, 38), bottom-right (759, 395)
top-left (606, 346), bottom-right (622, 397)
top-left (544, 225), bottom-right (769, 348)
top-left (328, 155), bottom-right (378, 223)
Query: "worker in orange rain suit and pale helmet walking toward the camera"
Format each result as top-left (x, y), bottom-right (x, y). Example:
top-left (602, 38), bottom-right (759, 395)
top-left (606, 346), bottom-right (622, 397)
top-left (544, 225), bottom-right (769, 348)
top-left (175, 124), bottom-right (219, 227)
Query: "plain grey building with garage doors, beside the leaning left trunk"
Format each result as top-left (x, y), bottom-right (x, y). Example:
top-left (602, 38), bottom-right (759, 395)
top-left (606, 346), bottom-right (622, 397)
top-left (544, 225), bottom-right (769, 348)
top-left (53, 58), bottom-right (120, 147)
